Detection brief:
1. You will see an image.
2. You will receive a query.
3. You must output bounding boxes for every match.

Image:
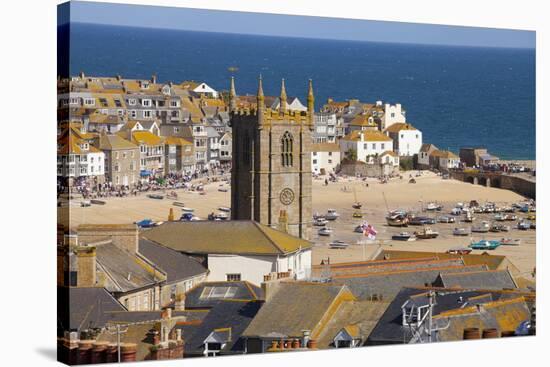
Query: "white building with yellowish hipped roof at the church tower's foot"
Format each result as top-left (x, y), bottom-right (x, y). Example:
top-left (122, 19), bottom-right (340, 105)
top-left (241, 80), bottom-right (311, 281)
top-left (143, 220), bottom-right (312, 285)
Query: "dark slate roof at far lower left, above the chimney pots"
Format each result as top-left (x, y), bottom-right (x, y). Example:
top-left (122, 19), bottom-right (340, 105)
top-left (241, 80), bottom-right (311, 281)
top-left (57, 287), bottom-right (126, 331)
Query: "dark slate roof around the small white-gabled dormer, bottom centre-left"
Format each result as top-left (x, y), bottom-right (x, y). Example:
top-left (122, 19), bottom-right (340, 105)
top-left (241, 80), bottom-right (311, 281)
top-left (176, 300), bottom-right (262, 356)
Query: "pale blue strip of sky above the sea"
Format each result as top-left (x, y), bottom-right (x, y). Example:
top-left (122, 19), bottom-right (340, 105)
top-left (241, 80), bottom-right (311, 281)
top-left (59, 1), bottom-right (535, 48)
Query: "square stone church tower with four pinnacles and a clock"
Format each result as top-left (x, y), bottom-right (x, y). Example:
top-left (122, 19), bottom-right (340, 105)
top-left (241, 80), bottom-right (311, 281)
top-left (229, 76), bottom-right (314, 239)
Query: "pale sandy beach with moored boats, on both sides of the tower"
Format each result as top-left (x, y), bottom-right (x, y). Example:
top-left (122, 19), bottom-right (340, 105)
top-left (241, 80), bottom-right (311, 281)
top-left (58, 171), bottom-right (536, 278)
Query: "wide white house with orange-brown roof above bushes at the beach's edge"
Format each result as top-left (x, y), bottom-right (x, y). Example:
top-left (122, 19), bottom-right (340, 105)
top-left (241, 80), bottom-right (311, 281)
top-left (340, 130), bottom-right (393, 163)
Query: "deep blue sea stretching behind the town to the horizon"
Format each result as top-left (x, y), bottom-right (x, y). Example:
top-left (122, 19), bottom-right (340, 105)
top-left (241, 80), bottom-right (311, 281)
top-left (62, 23), bottom-right (536, 160)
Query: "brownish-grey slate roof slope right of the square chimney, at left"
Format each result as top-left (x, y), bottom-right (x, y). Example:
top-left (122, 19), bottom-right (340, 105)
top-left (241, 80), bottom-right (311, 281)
top-left (96, 243), bottom-right (164, 292)
